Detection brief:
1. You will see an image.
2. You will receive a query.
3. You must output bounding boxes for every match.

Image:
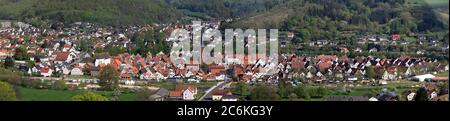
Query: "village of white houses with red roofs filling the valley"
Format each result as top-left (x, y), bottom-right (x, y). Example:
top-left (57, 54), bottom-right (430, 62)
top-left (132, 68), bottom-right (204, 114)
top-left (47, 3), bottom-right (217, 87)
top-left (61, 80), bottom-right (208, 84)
top-left (0, 22), bottom-right (449, 101)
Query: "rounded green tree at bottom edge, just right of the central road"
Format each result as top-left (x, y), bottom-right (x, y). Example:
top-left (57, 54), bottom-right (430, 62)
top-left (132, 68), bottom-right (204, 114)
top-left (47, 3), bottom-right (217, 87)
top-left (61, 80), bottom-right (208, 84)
top-left (250, 84), bottom-right (279, 101)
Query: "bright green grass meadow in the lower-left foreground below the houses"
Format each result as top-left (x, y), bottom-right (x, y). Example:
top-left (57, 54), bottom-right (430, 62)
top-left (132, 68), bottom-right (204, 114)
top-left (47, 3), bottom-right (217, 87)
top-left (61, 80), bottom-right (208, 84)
top-left (16, 87), bottom-right (136, 101)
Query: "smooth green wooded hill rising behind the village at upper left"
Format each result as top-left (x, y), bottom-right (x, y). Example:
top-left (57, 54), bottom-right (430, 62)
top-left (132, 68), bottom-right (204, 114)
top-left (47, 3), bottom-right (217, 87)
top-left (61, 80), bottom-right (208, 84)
top-left (0, 0), bottom-right (182, 25)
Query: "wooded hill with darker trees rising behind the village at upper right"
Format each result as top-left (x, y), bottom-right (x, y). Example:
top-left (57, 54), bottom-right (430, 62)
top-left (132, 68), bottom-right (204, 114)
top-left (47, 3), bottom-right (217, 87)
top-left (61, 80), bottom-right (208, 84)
top-left (228, 0), bottom-right (448, 40)
